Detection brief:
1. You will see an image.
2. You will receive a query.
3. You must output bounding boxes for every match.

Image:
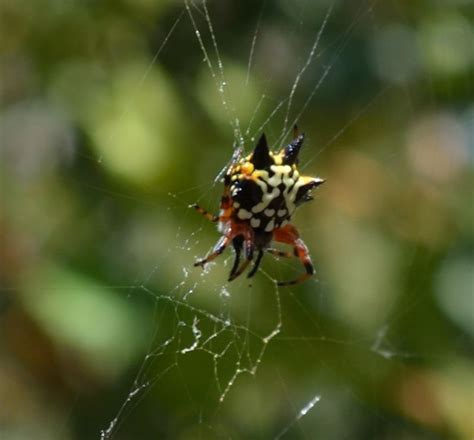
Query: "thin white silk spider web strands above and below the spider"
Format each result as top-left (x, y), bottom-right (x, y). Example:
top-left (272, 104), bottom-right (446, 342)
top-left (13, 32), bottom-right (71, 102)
top-left (96, 0), bottom-right (414, 439)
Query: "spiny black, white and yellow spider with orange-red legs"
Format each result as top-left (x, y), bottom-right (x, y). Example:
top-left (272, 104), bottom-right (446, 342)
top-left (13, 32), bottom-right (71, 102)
top-left (192, 126), bottom-right (324, 286)
